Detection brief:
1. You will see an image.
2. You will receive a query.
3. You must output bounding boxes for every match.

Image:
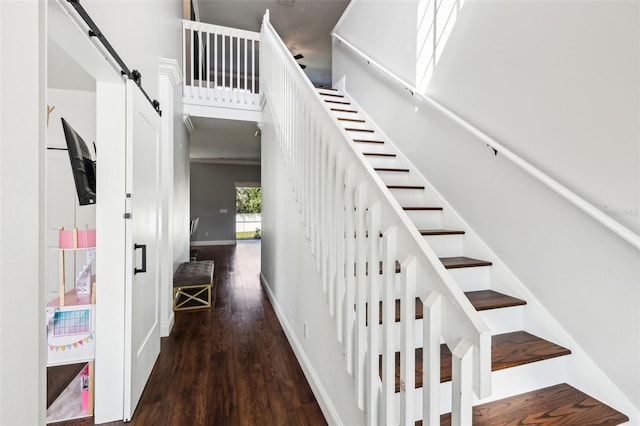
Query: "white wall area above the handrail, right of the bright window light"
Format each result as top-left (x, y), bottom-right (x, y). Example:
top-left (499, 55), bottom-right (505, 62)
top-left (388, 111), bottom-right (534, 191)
top-left (429, 1), bottom-right (640, 236)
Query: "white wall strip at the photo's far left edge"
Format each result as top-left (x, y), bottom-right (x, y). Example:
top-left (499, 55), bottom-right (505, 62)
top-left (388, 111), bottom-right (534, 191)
top-left (0, 1), bottom-right (46, 425)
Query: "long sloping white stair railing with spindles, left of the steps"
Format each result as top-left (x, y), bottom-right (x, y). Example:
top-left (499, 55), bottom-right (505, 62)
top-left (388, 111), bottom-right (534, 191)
top-left (260, 12), bottom-right (491, 425)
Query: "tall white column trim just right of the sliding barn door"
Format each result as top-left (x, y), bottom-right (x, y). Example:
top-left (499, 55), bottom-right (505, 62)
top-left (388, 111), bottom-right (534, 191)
top-left (158, 58), bottom-right (182, 337)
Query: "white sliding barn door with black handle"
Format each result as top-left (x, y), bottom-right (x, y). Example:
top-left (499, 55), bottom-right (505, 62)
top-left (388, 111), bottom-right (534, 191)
top-left (124, 80), bottom-right (161, 421)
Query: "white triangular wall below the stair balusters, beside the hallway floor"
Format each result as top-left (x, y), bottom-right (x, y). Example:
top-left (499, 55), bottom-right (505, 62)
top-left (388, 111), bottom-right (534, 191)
top-left (262, 107), bottom-right (366, 425)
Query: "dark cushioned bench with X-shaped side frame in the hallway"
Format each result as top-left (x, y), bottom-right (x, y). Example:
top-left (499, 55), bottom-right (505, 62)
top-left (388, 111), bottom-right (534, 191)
top-left (173, 260), bottom-right (214, 311)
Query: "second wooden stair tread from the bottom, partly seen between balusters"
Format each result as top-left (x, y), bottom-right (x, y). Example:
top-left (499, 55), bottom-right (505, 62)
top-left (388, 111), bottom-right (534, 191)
top-left (384, 331), bottom-right (571, 392)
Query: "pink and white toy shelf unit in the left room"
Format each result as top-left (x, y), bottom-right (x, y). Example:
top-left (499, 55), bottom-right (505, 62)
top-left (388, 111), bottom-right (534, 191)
top-left (47, 228), bottom-right (95, 422)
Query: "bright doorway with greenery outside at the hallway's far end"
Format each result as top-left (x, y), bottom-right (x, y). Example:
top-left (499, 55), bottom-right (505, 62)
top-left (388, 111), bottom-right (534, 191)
top-left (236, 182), bottom-right (262, 240)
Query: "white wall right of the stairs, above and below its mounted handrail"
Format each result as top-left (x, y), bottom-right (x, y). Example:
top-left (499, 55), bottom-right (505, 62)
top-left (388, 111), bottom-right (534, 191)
top-left (333, 1), bottom-right (640, 408)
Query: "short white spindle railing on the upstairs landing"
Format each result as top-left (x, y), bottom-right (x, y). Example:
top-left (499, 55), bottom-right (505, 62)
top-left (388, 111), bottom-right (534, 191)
top-left (182, 20), bottom-right (262, 110)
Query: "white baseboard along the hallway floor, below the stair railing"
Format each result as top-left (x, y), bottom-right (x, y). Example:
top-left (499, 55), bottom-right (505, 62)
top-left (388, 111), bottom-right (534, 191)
top-left (260, 273), bottom-right (343, 425)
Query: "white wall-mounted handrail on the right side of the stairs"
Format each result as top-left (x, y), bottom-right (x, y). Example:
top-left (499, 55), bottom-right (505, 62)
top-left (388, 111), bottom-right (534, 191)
top-left (331, 35), bottom-right (640, 250)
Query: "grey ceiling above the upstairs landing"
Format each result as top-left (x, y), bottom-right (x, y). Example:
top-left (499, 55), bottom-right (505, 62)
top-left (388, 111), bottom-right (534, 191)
top-left (194, 0), bottom-right (349, 86)
